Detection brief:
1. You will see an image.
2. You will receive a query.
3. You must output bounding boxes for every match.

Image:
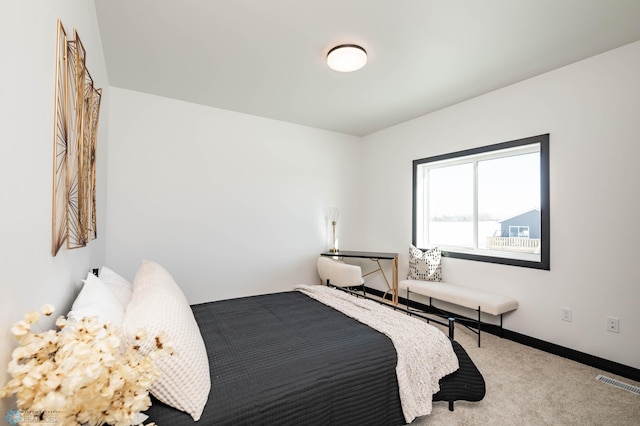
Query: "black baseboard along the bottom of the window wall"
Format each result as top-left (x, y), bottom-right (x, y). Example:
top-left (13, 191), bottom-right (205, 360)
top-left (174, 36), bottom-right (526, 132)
top-left (366, 287), bottom-right (640, 382)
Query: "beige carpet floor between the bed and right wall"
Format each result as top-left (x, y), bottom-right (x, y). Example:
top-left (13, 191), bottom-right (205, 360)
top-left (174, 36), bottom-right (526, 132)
top-left (412, 326), bottom-right (640, 426)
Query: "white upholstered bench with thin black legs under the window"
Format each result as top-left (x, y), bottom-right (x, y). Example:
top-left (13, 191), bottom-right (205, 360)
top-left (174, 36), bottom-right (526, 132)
top-left (398, 280), bottom-right (518, 347)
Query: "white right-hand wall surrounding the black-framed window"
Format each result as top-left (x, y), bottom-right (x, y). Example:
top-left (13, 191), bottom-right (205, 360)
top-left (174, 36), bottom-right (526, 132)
top-left (363, 42), bottom-right (640, 368)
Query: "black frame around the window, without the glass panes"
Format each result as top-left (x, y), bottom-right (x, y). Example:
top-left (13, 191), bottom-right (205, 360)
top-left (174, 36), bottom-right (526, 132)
top-left (411, 133), bottom-right (551, 271)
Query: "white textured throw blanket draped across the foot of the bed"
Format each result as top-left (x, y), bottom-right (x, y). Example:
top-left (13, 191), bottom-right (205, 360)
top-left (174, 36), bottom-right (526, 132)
top-left (296, 285), bottom-right (459, 423)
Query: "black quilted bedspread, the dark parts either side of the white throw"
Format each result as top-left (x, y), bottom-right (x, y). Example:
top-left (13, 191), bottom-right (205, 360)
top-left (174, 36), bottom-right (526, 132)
top-left (146, 291), bottom-right (485, 426)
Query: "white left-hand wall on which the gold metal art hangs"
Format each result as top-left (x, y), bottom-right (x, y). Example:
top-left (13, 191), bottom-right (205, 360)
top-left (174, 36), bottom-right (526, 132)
top-left (0, 0), bottom-right (109, 416)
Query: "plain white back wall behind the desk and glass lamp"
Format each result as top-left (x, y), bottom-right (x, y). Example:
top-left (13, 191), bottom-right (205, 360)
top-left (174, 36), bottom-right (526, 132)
top-left (107, 88), bottom-right (361, 303)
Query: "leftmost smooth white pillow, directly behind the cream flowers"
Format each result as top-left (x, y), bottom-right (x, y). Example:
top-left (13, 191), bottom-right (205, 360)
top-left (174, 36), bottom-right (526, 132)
top-left (68, 272), bottom-right (125, 326)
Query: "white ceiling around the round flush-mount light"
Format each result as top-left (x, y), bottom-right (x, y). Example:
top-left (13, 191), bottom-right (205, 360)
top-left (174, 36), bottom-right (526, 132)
top-left (94, 0), bottom-right (640, 136)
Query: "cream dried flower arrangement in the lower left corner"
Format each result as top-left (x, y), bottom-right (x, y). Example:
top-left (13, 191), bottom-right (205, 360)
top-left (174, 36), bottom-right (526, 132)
top-left (0, 305), bottom-right (173, 426)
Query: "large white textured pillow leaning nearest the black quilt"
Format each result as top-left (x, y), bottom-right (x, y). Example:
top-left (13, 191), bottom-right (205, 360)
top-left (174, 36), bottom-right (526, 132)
top-left (123, 260), bottom-right (211, 421)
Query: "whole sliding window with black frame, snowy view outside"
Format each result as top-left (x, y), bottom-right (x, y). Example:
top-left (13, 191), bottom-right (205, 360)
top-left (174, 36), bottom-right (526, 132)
top-left (413, 134), bottom-right (550, 270)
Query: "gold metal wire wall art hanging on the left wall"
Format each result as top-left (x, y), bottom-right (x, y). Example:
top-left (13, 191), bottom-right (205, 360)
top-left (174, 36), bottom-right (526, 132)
top-left (51, 20), bottom-right (102, 256)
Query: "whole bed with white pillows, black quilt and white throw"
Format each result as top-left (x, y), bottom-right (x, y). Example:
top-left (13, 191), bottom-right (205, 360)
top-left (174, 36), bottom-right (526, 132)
top-left (69, 260), bottom-right (485, 426)
